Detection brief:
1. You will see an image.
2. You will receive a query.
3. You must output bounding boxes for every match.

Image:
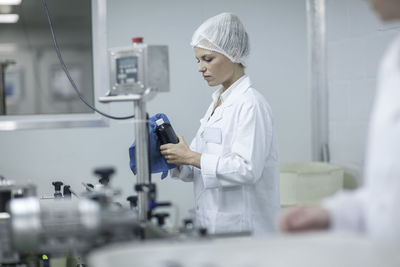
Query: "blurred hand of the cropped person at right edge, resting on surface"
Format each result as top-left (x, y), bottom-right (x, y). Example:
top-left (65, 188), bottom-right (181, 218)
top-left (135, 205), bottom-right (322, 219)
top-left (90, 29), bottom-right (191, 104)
top-left (279, 206), bottom-right (331, 233)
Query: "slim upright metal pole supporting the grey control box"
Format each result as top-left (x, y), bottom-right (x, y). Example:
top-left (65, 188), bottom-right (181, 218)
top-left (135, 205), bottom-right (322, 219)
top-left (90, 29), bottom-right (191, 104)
top-left (134, 100), bottom-right (150, 222)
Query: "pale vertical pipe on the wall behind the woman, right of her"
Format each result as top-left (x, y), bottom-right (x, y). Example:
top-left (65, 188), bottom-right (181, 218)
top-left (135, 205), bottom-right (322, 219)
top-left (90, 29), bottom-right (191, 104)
top-left (306, 0), bottom-right (330, 162)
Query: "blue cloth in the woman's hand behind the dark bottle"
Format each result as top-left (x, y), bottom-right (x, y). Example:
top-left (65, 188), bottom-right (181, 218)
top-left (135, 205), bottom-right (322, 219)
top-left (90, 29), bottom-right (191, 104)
top-left (129, 113), bottom-right (176, 179)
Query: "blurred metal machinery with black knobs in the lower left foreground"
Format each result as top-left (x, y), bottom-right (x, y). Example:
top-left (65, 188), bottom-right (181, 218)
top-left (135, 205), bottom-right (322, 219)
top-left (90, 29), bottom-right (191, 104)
top-left (0, 168), bottom-right (174, 267)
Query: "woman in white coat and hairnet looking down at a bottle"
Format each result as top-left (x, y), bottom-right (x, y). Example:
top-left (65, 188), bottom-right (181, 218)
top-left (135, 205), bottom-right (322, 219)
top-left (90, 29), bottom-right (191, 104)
top-left (160, 13), bottom-right (279, 235)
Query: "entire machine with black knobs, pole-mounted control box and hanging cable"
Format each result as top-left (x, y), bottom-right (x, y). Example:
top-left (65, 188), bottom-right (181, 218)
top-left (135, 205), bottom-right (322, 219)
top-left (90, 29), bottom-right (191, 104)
top-left (0, 0), bottom-right (245, 267)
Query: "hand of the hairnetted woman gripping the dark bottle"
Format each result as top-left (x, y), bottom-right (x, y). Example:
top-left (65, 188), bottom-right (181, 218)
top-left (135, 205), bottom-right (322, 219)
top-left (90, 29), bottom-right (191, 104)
top-left (160, 136), bottom-right (201, 168)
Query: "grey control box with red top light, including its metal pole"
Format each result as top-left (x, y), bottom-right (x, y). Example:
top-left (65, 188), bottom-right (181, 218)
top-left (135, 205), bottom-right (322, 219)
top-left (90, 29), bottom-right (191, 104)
top-left (100, 37), bottom-right (169, 222)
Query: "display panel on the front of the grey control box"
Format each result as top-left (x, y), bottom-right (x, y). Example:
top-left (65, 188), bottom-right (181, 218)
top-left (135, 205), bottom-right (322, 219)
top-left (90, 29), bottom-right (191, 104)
top-left (116, 56), bottom-right (138, 84)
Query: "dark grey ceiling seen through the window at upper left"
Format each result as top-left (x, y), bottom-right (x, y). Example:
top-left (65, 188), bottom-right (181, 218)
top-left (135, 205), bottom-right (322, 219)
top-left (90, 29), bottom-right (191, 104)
top-left (0, 0), bottom-right (92, 48)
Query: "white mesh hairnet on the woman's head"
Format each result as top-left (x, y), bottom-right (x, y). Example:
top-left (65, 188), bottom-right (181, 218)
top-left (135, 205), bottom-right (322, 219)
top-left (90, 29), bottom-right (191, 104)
top-left (190, 13), bottom-right (250, 66)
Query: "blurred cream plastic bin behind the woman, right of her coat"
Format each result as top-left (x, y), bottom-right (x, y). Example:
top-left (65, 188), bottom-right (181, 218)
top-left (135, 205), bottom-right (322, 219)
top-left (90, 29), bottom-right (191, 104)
top-left (280, 162), bottom-right (343, 207)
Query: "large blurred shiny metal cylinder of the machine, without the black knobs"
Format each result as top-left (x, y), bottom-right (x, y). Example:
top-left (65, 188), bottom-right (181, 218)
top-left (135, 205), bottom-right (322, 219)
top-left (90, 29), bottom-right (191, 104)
top-left (10, 197), bottom-right (141, 256)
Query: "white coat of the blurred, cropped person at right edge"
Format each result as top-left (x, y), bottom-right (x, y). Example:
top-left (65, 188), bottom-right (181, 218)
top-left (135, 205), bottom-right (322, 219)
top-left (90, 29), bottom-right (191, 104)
top-left (324, 36), bottom-right (400, 242)
